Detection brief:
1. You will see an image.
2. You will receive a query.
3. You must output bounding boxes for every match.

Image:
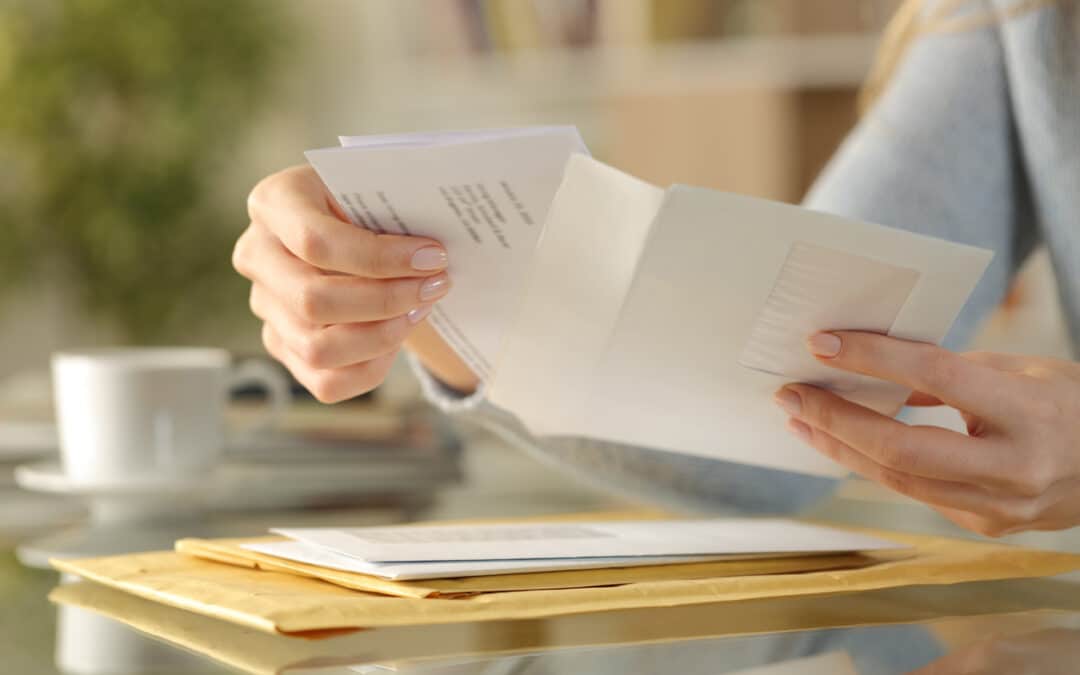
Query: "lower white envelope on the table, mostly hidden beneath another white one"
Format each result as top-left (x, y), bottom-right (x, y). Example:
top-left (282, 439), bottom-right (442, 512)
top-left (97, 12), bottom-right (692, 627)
top-left (240, 541), bottom-right (759, 581)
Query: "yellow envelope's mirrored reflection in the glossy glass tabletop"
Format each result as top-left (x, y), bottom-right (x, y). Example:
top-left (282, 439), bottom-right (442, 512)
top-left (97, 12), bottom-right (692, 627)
top-left (50, 579), bottom-right (1080, 675)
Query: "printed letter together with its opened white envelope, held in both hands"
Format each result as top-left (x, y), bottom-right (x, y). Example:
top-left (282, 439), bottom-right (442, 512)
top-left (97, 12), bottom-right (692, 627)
top-left (307, 127), bottom-right (991, 475)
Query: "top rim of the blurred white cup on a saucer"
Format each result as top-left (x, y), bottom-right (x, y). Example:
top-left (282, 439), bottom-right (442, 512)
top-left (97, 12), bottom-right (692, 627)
top-left (52, 347), bottom-right (232, 370)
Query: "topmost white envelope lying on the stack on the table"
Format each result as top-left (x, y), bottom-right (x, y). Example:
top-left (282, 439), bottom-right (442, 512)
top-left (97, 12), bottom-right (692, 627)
top-left (273, 518), bottom-right (904, 563)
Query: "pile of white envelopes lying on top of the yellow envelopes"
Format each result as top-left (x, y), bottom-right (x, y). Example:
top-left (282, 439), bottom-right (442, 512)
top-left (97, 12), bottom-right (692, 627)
top-left (232, 518), bottom-right (905, 580)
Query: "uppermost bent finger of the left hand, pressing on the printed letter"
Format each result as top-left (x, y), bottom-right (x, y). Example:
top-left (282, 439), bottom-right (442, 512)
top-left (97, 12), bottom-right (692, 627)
top-left (248, 166), bottom-right (447, 279)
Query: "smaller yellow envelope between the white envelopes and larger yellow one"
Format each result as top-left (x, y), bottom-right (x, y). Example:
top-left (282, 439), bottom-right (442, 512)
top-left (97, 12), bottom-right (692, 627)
top-left (176, 537), bottom-right (885, 597)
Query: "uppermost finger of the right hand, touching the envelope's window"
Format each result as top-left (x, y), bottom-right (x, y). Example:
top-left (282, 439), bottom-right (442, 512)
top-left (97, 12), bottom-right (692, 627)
top-left (808, 330), bottom-right (1010, 414)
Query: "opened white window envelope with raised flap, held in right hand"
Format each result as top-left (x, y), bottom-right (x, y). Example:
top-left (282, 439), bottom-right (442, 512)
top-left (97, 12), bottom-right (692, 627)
top-left (490, 157), bottom-right (991, 475)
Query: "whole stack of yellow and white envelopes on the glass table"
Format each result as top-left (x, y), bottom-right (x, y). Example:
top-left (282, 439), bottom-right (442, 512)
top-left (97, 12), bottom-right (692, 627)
top-left (54, 517), bottom-right (1080, 636)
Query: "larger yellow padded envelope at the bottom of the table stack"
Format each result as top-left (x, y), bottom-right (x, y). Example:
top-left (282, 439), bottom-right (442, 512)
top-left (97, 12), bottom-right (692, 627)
top-left (53, 530), bottom-right (1080, 634)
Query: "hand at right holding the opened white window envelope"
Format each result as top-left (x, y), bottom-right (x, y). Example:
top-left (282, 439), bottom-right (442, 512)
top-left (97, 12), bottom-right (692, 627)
top-left (775, 330), bottom-right (1080, 537)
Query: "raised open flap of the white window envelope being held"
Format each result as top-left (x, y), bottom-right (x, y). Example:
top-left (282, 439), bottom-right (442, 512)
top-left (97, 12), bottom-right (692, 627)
top-left (487, 154), bottom-right (664, 430)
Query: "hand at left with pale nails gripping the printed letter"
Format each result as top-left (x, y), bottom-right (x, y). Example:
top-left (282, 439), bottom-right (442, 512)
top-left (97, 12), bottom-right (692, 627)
top-left (232, 166), bottom-right (462, 403)
